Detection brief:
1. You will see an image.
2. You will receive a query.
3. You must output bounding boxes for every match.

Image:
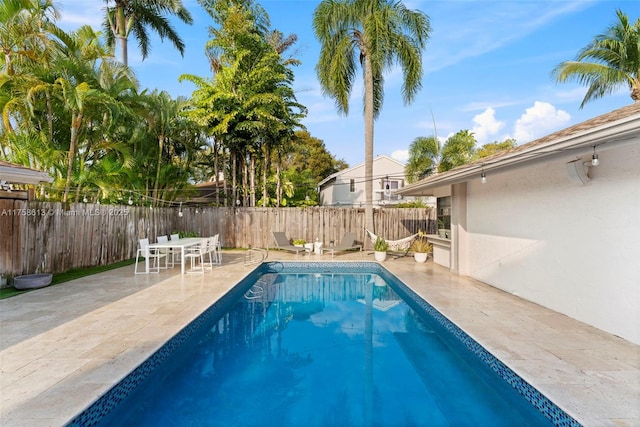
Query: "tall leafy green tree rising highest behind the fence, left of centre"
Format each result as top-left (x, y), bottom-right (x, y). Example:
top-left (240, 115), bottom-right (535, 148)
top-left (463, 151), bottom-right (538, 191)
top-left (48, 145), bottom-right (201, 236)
top-left (181, 0), bottom-right (306, 206)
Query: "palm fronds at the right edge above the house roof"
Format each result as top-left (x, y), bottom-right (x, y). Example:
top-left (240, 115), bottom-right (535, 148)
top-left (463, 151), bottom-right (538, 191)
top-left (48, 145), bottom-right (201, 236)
top-left (552, 10), bottom-right (640, 108)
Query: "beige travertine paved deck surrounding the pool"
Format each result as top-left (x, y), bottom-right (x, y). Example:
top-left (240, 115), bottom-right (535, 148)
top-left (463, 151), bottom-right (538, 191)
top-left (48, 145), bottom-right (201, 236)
top-left (0, 251), bottom-right (640, 427)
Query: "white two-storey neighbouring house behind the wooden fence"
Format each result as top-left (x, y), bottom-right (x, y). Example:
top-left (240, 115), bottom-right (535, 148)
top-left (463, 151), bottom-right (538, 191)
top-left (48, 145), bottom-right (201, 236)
top-left (318, 156), bottom-right (413, 207)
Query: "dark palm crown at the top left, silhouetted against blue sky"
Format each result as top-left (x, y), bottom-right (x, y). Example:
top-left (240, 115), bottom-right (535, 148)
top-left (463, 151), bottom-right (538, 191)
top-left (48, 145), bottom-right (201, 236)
top-left (103, 0), bottom-right (193, 65)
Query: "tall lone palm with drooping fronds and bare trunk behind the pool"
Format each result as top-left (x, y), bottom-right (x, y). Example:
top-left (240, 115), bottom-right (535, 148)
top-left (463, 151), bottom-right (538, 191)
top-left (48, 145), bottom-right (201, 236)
top-left (313, 0), bottom-right (431, 239)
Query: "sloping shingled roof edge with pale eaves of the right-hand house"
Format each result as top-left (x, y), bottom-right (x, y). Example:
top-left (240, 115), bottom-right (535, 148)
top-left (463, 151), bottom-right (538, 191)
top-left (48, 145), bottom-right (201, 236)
top-left (397, 102), bottom-right (640, 196)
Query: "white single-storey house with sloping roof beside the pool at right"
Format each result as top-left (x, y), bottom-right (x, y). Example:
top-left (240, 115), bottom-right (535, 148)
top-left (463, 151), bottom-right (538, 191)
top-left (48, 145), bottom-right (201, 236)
top-left (399, 102), bottom-right (640, 344)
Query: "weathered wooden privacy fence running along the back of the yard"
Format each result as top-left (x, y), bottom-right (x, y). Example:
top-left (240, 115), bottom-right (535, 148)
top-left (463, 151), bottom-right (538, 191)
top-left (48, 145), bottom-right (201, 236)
top-left (0, 199), bottom-right (436, 275)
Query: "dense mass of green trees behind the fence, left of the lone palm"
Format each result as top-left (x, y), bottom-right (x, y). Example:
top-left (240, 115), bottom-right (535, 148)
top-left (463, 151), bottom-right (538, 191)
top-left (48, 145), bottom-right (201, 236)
top-left (0, 0), bottom-right (339, 206)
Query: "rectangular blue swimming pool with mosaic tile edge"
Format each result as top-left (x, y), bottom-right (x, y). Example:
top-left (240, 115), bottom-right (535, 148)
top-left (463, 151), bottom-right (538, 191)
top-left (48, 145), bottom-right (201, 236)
top-left (69, 262), bottom-right (579, 427)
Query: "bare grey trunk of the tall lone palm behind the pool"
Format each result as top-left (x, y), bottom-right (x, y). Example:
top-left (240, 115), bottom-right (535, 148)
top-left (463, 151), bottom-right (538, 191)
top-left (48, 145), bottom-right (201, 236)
top-left (364, 57), bottom-right (375, 249)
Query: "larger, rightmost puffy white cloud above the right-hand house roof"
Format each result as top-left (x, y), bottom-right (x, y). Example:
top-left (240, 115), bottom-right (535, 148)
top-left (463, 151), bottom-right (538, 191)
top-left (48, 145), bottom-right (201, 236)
top-left (514, 101), bottom-right (571, 144)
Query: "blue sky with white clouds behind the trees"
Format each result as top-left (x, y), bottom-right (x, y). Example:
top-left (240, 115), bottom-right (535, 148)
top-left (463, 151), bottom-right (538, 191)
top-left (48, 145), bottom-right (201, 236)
top-left (55, 0), bottom-right (640, 166)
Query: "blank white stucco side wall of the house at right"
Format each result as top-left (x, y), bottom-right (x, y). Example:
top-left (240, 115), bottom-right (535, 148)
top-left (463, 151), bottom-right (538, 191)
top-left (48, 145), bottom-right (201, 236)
top-left (454, 140), bottom-right (640, 344)
